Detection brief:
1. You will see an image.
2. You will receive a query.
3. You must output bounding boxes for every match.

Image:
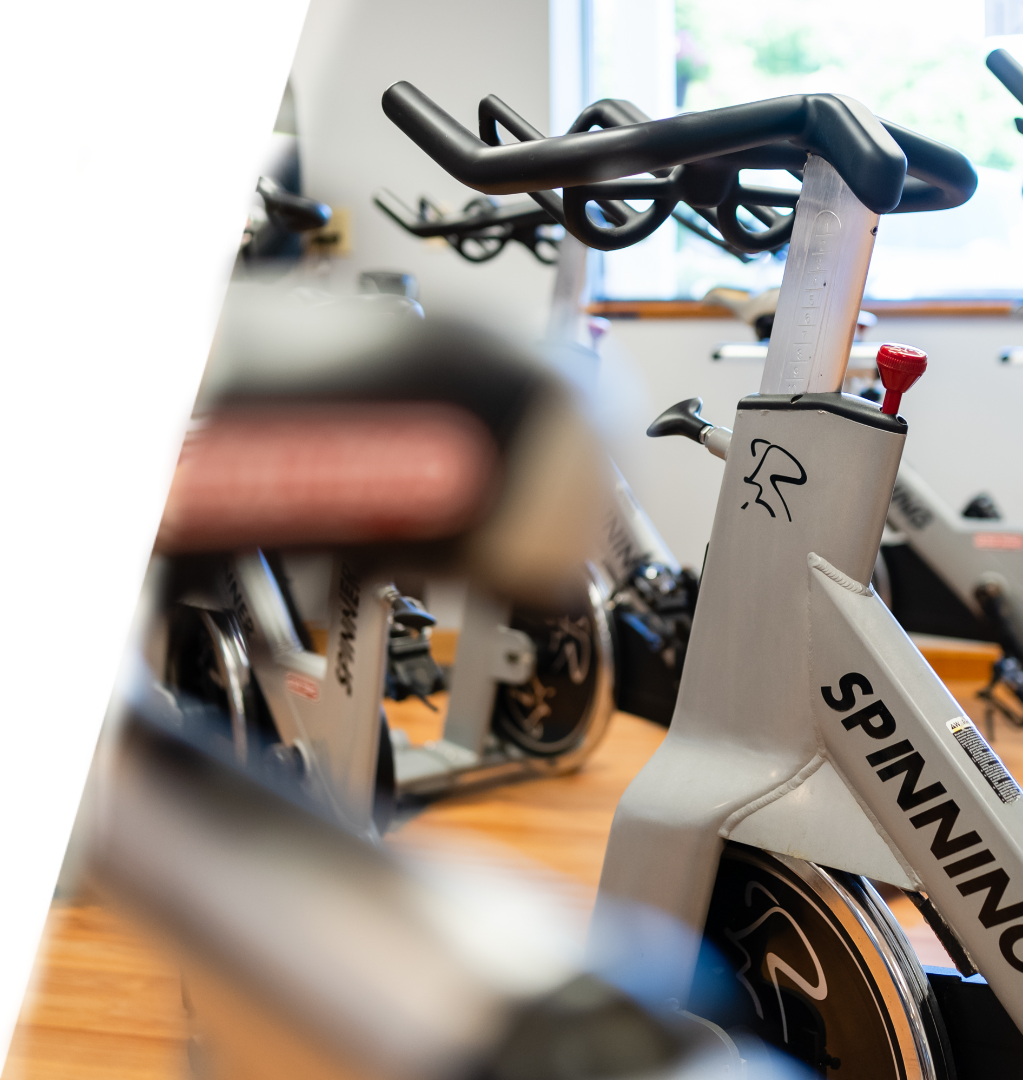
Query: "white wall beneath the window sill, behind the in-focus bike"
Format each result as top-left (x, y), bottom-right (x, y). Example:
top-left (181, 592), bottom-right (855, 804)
top-left (604, 319), bottom-right (1023, 567)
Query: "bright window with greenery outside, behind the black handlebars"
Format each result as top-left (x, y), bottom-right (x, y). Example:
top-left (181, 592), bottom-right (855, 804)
top-left (580, 0), bottom-right (1023, 299)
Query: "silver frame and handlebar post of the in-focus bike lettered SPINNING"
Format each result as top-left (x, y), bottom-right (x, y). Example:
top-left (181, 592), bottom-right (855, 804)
top-left (592, 157), bottom-right (1023, 1027)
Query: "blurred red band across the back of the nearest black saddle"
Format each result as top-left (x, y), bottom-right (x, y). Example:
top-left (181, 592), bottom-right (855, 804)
top-left (156, 402), bottom-right (501, 554)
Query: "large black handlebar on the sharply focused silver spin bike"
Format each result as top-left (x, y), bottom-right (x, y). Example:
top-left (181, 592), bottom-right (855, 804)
top-left (382, 82), bottom-right (977, 251)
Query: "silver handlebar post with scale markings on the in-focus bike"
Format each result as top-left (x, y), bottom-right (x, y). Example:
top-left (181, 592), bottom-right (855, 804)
top-left (760, 154), bottom-right (878, 395)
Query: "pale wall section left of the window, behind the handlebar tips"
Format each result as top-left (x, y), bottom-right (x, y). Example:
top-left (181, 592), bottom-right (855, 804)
top-left (292, 0), bottom-right (554, 339)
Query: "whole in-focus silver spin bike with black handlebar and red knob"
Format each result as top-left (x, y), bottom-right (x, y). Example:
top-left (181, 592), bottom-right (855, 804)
top-left (383, 73), bottom-right (1023, 1078)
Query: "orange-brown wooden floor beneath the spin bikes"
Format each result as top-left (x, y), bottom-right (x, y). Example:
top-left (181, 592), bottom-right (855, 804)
top-left (2, 643), bottom-right (1023, 1080)
